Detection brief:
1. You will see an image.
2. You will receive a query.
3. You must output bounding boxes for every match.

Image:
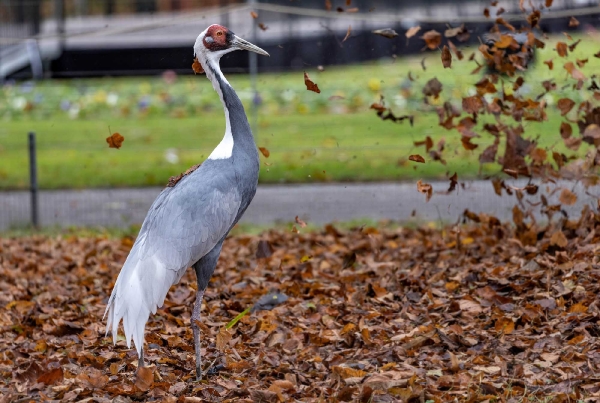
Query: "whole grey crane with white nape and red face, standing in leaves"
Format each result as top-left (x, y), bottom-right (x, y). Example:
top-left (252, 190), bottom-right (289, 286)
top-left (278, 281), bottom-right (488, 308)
top-left (105, 24), bottom-right (269, 379)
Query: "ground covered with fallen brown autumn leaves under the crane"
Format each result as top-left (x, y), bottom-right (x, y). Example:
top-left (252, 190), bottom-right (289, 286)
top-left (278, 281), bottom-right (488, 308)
top-left (0, 207), bottom-right (600, 403)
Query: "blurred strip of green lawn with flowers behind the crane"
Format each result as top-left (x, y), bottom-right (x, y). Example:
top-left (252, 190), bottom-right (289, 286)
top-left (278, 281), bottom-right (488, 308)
top-left (0, 33), bottom-right (600, 189)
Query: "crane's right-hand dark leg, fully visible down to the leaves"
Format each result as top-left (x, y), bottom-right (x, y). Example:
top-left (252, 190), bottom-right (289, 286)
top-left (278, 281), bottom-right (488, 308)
top-left (191, 239), bottom-right (223, 380)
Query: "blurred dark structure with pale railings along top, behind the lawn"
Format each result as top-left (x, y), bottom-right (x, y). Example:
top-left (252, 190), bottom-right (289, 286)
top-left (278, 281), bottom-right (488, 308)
top-left (0, 0), bottom-right (600, 80)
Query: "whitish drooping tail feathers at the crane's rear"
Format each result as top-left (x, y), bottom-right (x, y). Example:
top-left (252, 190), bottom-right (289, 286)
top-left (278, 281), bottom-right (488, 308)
top-left (104, 242), bottom-right (183, 356)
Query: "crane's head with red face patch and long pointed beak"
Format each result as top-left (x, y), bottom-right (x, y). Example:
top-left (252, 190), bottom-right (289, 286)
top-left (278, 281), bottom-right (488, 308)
top-left (194, 24), bottom-right (269, 57)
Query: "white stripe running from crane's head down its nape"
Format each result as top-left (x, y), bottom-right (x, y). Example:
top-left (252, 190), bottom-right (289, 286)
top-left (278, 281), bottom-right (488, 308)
top-left (194, 30), bottom-right (235, 160)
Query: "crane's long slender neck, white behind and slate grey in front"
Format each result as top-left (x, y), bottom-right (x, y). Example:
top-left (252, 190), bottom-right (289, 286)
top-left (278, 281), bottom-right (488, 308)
top-left (205, 59), bottom-right (256, 159)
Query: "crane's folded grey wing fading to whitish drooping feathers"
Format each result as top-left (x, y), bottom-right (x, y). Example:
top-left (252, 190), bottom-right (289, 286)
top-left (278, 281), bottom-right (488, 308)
top-left (105, 167), bottom-right (241, 354)
